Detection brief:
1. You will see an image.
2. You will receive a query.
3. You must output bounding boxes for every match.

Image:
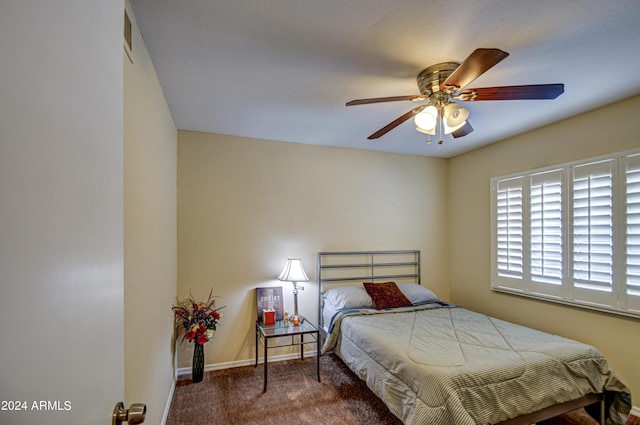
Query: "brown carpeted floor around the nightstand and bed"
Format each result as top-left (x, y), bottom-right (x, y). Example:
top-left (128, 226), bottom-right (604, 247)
top-left (167, 354), bottom-right (640, 425)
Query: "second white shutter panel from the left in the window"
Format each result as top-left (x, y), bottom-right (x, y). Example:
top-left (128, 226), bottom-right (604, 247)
top-left (530, 170), bottom-right (562, 285)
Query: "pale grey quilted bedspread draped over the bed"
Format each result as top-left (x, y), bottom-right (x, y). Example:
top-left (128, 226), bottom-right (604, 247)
top-left (323, 304), bottom-right (630, 425)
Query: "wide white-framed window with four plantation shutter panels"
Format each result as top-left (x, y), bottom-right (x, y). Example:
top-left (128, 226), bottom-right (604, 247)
top-left (491, 151), bottom-right (640, 317)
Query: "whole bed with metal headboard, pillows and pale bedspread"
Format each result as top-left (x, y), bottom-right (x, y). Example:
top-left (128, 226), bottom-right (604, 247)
top-left (318, 250), bottom-right (631, 425)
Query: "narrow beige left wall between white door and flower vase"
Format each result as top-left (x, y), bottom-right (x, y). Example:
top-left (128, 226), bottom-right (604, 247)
top-left (124, 5), bottom-right (177, 424)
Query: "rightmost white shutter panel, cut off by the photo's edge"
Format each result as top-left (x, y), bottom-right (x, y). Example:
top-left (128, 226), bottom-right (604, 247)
top-left (625, 155), bottom-right (640, 310)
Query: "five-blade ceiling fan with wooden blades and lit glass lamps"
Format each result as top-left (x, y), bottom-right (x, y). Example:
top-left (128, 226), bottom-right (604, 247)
top-left (347, 49), bottom-right (564, 144)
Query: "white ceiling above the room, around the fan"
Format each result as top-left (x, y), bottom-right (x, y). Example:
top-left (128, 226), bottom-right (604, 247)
top-left (131, 0), bottom-right (640, 158)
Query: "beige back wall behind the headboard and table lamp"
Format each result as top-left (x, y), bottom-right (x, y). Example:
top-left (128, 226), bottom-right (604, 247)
top-left (178, 131), bottom-right (449, 367)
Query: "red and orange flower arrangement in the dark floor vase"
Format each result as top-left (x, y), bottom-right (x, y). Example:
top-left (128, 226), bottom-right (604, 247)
top-left (172, 291), bottom-right (225, 345)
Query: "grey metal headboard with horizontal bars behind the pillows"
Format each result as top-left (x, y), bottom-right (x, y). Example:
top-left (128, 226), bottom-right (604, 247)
top-left (318, 250), bottom-right (421, 338)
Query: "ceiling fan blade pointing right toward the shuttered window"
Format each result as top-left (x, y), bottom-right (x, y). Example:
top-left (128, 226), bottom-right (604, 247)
top-left (455, 84), bottom-right (564, 102)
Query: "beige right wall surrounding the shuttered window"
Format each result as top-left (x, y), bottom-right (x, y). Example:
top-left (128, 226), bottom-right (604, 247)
top-left (448, 97), bottom-right (640, 398)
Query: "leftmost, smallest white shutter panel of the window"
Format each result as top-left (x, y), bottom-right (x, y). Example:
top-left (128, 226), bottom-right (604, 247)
top-left (496, 178), bottom-right (523, 278)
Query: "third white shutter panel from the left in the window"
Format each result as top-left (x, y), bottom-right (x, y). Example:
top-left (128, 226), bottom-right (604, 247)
top-left (573, 160), bottom-right (614, 292)
